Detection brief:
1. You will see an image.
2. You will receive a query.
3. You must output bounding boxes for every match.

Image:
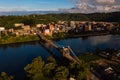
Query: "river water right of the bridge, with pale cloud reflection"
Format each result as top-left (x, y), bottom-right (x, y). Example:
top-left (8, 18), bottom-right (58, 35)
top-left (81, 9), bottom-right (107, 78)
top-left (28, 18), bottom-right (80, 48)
top-left (57, 35), bottom-right (120, 54)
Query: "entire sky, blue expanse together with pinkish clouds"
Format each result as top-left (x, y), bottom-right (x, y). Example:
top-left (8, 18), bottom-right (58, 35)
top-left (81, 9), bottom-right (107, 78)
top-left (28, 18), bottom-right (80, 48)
top-left (0, 0), bottom-right (120, 13)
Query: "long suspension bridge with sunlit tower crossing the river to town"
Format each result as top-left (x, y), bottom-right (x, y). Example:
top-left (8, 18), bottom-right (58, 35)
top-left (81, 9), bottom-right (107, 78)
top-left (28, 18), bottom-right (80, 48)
top-left (37, 33), bottom-right (80, 64)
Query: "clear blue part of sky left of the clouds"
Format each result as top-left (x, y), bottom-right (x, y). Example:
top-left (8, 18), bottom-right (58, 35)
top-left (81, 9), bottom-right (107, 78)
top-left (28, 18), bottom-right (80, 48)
top-left (0, 0), bottom-right (74, 11)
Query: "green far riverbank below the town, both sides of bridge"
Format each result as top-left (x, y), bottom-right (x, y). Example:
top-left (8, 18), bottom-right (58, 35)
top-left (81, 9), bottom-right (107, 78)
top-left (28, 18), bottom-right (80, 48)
top-left (0, 32), bottom-right (119, 44)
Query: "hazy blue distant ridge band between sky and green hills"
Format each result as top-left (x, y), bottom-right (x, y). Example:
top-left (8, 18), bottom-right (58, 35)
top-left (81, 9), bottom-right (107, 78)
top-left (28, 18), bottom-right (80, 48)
top-left (0, 11), bottom-right (120, 16)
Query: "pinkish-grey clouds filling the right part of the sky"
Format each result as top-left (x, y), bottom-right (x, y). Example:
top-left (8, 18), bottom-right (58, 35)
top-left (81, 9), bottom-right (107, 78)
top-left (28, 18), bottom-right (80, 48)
top-left (62, 0), bottom-right (120, 13)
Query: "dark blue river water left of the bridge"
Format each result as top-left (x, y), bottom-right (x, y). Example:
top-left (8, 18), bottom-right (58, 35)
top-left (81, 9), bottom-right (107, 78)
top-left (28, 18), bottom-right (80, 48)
top-left (0, 42), bottom-right (50, 80)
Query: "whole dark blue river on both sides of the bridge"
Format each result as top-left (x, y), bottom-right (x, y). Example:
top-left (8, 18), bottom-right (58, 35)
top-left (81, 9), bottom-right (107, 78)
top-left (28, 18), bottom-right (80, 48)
top-left (0, 35), bottom-right (120, 80)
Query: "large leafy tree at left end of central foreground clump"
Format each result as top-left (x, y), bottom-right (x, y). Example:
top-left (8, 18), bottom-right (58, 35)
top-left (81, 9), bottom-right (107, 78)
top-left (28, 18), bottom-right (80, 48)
top-left (24, 57), bottom-right (45, 80)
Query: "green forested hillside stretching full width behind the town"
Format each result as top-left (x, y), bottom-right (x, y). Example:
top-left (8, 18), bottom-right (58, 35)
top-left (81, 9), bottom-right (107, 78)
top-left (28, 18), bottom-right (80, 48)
top-left (0, 12), bottom-right (120, 29)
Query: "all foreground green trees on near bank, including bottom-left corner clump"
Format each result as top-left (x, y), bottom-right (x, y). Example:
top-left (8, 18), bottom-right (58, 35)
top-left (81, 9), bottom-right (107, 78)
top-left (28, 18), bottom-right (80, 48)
top-left (0, 55), bottom-right (99, 80)
